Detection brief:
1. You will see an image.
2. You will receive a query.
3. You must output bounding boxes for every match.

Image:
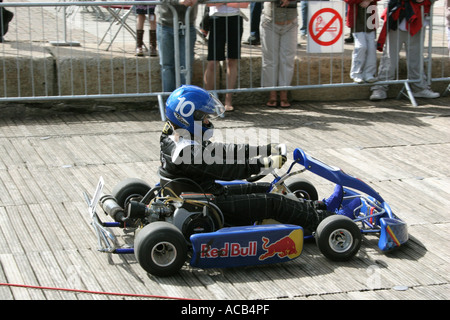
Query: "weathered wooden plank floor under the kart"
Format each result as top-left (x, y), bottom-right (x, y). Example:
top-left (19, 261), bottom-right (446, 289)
top-left (0, 97), bottom-right (450, 300)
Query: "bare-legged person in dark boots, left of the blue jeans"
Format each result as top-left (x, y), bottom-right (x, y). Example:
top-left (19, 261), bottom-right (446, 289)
top-left (135, 0), bottom-right (158, 57)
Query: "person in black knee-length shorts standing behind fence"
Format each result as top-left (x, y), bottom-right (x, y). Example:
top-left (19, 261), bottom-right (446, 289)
top-left (203, 3), bottom-right (244, 111)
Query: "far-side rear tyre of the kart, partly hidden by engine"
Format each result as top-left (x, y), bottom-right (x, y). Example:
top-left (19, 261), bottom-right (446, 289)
top-left (112, 178), bottom-right (150, 208)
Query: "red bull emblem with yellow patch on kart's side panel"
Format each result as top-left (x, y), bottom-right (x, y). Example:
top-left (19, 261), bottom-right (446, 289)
top-left (259, 229), bottom-right (303, 261)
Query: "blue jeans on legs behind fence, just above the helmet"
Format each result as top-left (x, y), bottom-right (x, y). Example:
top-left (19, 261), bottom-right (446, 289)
top-left (156, 24), bottom-right (197, 92)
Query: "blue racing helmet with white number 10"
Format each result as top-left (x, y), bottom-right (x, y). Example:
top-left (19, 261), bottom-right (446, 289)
top-left (166, 85), bottom-right (225, 136)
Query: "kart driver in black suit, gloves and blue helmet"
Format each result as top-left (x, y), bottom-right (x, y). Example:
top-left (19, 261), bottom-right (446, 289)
top-left (160, 85), bottom-right (354, 231)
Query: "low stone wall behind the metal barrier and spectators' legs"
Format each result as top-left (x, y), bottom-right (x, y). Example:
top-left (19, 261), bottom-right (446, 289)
top-left (0, 43), bottom-right (450, 104)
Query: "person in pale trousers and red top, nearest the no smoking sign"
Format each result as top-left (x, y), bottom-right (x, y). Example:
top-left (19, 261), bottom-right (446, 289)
top-left (344, 0), bottom-right (378, 83)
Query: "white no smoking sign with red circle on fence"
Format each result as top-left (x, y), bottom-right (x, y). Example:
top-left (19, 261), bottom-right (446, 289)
top-left (308, 1), bottom-right (344, 53)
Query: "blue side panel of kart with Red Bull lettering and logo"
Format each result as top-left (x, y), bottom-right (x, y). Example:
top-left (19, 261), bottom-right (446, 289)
top-left (191, 224), bottom-right (303, 268)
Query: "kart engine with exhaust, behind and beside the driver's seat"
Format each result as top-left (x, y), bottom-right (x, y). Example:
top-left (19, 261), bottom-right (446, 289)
top-left (100, 194), bottom-right (224, 241)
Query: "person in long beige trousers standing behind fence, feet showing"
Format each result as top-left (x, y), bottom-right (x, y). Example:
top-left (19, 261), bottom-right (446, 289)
top-left (261, 0), bottom-right (298, 108)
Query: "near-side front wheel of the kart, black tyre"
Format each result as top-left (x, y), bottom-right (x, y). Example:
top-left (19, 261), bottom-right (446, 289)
top-left (315, 215), bottom-right (362, 261)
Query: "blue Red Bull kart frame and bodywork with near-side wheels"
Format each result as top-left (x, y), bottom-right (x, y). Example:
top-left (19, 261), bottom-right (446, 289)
top-left (84, 148), bottom-right (408, 276)
